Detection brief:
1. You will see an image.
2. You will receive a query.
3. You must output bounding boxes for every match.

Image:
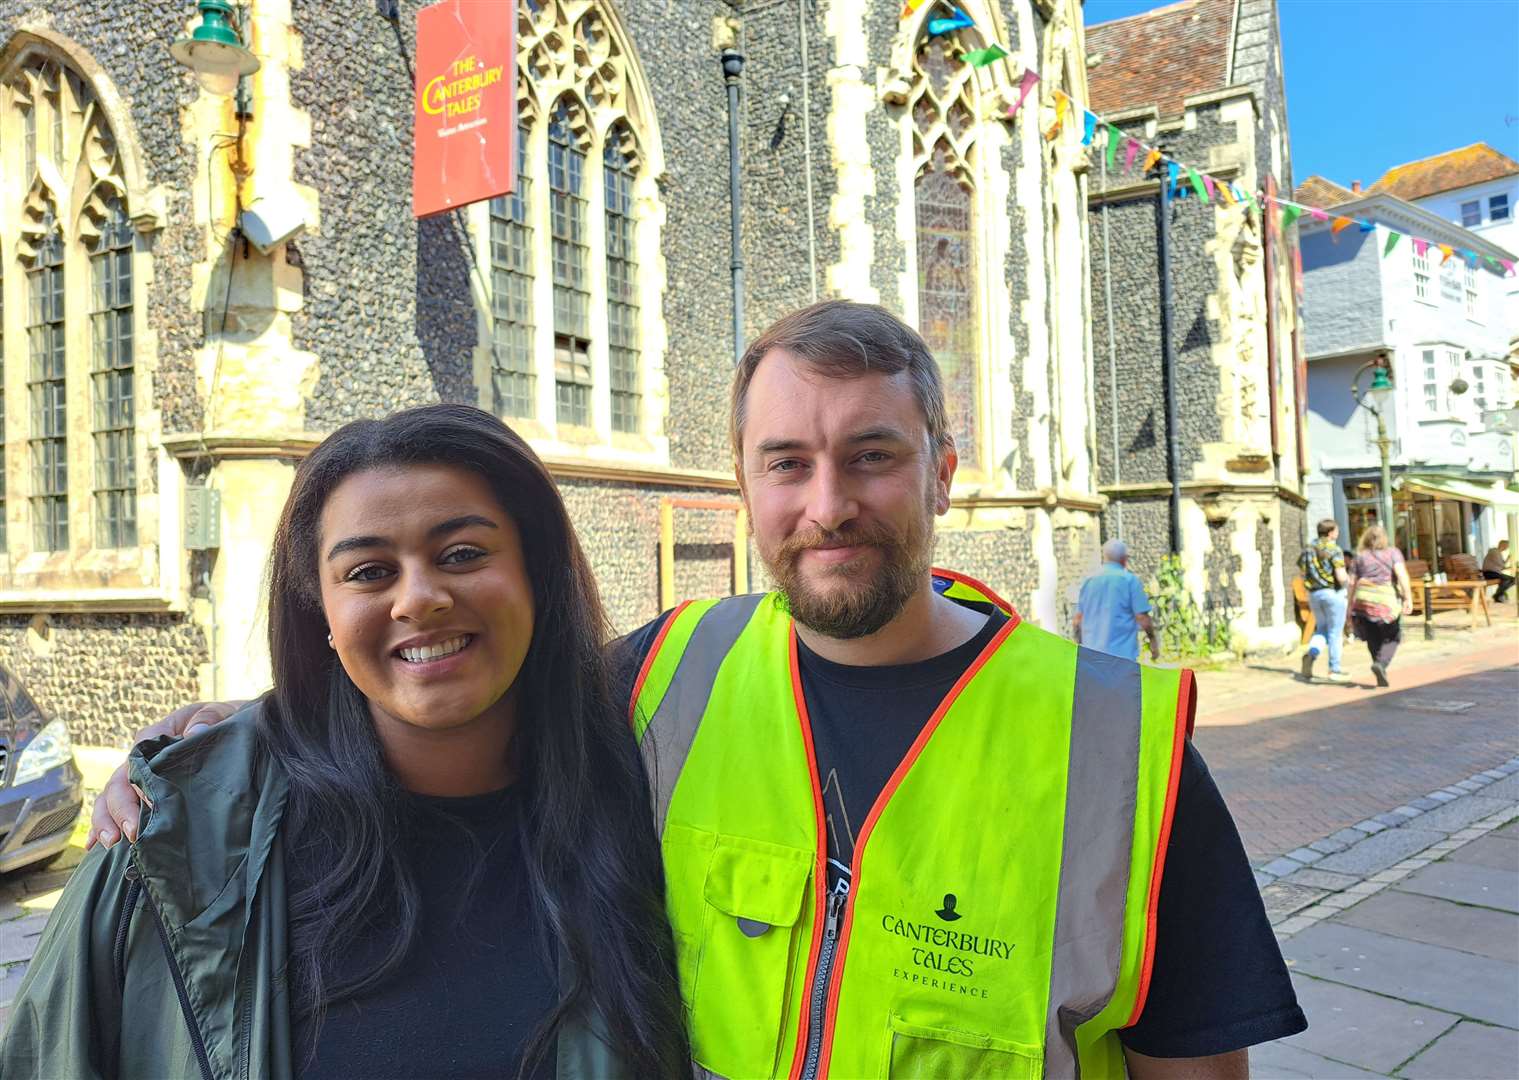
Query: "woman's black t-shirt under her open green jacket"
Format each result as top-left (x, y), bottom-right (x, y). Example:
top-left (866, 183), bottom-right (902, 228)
top-left (286, 788), bottom-right (557, 1080)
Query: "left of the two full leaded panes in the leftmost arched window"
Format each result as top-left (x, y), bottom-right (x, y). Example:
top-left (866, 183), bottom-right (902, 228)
top-left (27, 211), bottom-right (68, 551)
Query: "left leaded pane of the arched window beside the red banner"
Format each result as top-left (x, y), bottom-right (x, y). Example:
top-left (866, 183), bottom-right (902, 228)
top-left (491, 128), bottom-right (536, 416)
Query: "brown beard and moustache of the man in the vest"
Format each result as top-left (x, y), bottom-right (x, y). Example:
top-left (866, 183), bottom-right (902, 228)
top-left (760, 510), bottom-right (934, 641)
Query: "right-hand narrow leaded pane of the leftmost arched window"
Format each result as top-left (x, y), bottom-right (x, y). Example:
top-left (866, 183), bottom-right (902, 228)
top-left (90, 199), bottom-right (137, 547)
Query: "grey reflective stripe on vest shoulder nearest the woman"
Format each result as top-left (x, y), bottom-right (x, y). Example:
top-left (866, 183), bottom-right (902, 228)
top-left (641, 592), bottom-right (767, 835)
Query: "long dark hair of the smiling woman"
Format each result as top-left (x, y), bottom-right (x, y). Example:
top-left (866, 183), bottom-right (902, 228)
top-left (261, 406), bottom-right (690, 1077)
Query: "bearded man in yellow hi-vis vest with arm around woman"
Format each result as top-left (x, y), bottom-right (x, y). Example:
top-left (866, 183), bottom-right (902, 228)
top-left (86, 301), bottom-right (1306, 1080)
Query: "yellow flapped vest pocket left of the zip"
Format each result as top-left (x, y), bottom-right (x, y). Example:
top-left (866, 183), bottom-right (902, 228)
top-left (691, 834), bottom-right (813, 1077)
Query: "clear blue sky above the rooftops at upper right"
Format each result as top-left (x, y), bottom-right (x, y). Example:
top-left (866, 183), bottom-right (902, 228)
top-left (1086, 0), bottom-right (1519, 187)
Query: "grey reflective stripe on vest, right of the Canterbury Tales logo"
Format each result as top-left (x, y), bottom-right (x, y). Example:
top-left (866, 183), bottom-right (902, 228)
top-left (1045, 649), bottom-right (1141, 1077)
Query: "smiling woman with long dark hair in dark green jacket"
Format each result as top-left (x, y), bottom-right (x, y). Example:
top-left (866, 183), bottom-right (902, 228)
top-left (0, 406), bottom-right (688, 1077)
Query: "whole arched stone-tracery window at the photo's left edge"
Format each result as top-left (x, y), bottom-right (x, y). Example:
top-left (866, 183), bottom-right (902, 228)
top-left (0, 46), bottom-right (138, 551)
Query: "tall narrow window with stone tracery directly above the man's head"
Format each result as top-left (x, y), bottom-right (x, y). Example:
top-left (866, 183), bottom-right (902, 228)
top-left (907, 35), bottom-right (981, 468)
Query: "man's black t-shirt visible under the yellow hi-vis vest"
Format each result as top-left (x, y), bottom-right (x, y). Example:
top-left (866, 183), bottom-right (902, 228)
top-left (614, 605), bottom-right (1308, 1057)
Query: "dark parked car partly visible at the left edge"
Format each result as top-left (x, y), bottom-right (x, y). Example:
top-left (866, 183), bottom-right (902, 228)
top-left (0, 667), bottom-right (84, 872)
